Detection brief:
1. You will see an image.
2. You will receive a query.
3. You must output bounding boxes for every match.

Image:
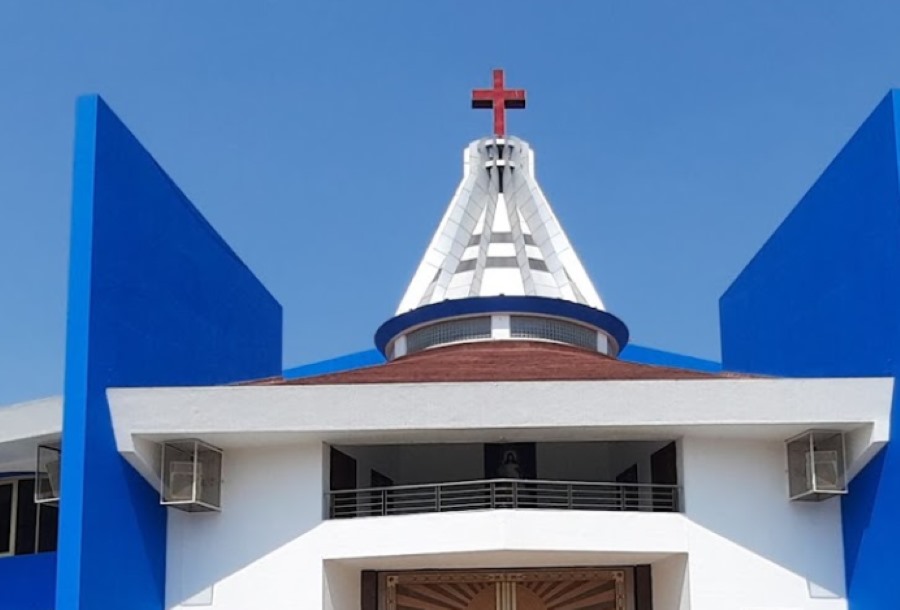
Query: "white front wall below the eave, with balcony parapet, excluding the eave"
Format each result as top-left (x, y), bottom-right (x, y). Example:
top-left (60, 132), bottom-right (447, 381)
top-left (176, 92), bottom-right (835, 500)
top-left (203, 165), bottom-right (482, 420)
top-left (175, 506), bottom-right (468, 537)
top-left (167, 438), bottom-right (846, 610)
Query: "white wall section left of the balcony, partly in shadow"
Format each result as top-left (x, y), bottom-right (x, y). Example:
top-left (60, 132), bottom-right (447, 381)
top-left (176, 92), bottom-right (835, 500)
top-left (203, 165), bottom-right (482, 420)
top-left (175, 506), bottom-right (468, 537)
top-left (166, 443), bottom-right (325, 610)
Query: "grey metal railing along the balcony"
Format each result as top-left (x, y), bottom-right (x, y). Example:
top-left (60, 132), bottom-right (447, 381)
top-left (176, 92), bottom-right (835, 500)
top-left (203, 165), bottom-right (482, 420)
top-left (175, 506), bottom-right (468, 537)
top-left (325, 479), bottom-right (679, 519)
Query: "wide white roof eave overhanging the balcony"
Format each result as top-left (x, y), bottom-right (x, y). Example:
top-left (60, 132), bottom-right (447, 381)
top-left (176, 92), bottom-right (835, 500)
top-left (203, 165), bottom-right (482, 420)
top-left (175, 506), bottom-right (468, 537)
top-left (108, 378), bottom-right (894, 484)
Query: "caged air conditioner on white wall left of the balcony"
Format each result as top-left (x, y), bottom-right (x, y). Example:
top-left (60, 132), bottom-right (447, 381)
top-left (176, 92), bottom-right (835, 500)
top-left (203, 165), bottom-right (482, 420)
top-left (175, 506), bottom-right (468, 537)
top-left (160, 439), bottom-right (223, 513)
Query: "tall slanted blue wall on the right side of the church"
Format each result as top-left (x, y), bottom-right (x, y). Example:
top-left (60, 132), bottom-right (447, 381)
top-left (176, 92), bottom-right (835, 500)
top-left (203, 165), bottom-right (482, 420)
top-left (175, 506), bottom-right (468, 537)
top-left (720, 92), bottom-right (900, 610)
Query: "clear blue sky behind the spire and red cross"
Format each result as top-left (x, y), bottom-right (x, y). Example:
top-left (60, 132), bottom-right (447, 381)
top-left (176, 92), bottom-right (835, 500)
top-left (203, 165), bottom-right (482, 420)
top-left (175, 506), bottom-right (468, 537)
top-left (0, 0), bottom-right (900, 404)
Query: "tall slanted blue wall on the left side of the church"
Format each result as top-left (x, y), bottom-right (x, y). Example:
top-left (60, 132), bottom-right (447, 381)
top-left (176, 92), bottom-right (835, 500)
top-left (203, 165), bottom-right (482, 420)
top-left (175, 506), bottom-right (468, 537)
top-left (56, 96), bottom-right (281, 610)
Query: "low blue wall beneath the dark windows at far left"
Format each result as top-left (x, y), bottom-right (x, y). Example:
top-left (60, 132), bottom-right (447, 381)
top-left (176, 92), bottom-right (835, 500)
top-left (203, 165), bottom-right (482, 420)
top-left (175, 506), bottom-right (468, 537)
top-left (0, 553), bottom-right (56, 610)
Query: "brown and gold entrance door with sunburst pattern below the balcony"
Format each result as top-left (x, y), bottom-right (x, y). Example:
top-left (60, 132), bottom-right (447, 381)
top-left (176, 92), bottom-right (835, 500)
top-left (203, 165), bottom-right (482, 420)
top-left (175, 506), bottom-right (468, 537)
top-left (382, 568), bottom-right (626, 610)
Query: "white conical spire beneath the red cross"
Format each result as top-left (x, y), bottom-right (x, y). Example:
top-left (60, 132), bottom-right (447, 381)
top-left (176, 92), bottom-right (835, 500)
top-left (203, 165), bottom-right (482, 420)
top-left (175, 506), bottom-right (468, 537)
top-left (397, 137), bottom-right (604, 314)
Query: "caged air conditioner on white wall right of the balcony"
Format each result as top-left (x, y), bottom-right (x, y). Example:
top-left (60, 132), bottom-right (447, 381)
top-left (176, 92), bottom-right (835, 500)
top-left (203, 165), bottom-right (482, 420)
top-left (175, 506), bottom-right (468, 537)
top-left (786, 430), bottom-right (847, 501)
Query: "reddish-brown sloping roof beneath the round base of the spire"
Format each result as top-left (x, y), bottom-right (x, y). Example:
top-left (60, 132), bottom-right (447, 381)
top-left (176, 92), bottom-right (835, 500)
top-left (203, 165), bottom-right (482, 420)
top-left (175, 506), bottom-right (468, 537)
top-left (251, 341), bottom-right (740, 385)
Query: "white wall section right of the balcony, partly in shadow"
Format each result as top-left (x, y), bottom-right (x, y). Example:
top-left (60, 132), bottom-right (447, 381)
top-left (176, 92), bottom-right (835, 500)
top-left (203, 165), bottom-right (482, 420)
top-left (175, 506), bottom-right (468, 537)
top-left (682, 438), bottom-right (847, 610)
